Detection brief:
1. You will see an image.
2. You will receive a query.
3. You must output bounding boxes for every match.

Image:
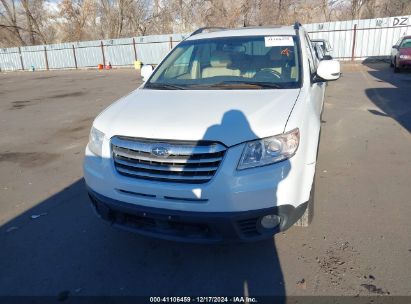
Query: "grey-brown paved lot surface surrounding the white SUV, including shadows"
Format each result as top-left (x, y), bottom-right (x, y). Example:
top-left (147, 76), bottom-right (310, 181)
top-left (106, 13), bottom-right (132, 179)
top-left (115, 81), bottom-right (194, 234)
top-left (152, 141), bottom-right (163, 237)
top-left (0, 63), bottom-right (411, 300)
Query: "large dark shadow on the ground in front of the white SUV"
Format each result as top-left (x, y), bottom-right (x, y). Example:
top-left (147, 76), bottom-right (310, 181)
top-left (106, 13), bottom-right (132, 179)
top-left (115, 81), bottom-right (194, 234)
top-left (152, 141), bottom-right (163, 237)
top-left (0, 180), bottom-right (284, 297)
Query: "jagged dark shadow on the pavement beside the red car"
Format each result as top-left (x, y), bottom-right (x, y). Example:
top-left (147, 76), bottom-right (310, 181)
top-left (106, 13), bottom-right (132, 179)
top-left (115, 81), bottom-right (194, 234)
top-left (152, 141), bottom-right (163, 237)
top-left (364, 62), bottom-right (411, 132)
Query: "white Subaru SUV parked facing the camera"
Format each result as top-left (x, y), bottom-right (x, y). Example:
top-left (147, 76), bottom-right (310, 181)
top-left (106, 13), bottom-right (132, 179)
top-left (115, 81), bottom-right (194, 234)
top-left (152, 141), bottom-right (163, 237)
top-left (84, 24), bottom-right (340, 242)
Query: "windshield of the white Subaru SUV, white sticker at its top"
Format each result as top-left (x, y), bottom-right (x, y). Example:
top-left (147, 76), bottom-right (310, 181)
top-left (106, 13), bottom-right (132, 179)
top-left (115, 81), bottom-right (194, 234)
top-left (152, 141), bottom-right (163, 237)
top-left (145, 36), bottom-right (300, 90)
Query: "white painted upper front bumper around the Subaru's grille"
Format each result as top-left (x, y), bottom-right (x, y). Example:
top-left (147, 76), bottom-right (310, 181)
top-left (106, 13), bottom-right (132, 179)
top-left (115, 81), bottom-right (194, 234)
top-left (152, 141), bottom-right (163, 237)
top-left (84, 140), bottom-right (315, 213)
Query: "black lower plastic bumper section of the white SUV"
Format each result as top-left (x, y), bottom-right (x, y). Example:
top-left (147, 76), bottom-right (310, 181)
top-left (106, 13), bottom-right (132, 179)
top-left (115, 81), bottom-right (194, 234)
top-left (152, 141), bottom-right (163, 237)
top-left (88, 188), bottom-right (307, 243)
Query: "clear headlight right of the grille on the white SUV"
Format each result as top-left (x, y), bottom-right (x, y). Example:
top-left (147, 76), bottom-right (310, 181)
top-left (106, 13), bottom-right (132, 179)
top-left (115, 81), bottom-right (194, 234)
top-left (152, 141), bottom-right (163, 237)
top-left (237, 129), bottom-right (300, 170)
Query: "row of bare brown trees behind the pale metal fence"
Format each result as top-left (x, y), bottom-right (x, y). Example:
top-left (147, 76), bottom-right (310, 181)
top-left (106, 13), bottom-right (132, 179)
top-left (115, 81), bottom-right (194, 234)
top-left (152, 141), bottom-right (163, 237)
top-left (0, 0), bottom-right (411, 46)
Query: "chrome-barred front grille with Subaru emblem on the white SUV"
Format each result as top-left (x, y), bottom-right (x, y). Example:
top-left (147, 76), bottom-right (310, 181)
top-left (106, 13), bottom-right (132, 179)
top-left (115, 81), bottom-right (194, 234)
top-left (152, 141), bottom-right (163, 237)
top-left (111, 136), bottom-right (226, 184)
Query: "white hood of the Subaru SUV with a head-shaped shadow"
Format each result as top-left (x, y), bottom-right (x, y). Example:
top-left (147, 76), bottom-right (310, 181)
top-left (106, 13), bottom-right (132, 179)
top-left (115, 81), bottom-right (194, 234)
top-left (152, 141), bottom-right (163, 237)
top-left (94, 89), bottom-right (300, 146)
